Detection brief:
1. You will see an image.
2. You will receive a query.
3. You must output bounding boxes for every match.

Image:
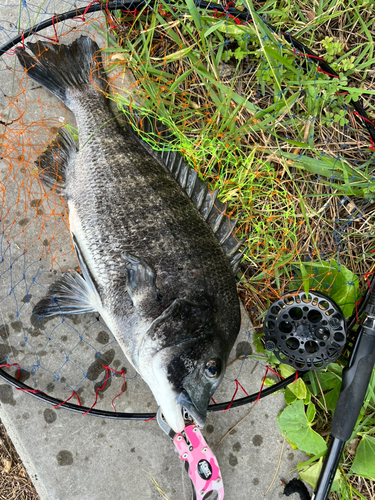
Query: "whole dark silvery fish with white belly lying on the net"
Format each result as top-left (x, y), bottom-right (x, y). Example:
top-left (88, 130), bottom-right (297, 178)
top-left (16, 36), bottom-right (243, 432)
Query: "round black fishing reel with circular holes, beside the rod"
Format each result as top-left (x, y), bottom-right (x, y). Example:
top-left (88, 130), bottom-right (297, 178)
top-left (263, 291), bottom-right (346, 371)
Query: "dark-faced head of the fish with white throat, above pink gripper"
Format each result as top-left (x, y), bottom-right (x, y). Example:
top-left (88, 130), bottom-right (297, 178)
top-left (141, 301), bottom-right (238, 432)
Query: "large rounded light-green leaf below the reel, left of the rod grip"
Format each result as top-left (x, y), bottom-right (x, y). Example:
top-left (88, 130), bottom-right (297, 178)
top-left (277, 400), bottom-right (327, 455)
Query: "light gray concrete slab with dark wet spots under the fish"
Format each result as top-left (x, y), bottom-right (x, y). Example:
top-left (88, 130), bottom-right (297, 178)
top-left (0, 2), bottom-right (312, 500)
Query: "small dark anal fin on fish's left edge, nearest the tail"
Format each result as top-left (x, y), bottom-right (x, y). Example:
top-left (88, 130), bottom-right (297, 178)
top-left (35, 127), bottom-right (77, 197)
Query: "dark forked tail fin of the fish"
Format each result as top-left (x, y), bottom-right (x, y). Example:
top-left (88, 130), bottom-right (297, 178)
top-left (16, 36), bottom-right (107, 107)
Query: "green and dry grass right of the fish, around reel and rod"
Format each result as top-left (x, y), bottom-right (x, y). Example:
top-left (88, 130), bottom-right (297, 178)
top-left (101, 0), bottom-right (375, 499)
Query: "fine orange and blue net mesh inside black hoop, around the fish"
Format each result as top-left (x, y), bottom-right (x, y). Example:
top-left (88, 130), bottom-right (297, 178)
top-left (0, 1), bottom-right (375, 411)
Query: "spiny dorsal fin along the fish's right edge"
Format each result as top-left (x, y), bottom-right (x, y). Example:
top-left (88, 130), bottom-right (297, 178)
top-left (125, 109), bottom-right (244, 274)
